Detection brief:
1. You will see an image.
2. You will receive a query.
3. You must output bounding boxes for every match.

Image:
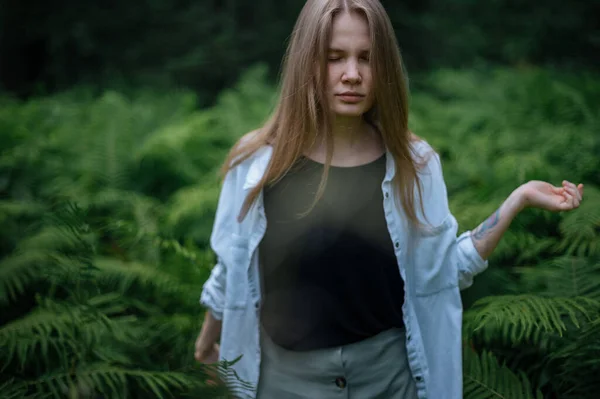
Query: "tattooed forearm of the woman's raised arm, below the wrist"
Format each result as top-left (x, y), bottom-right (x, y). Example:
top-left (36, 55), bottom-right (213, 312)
top-left (471, 189), bottom-right (525, 259)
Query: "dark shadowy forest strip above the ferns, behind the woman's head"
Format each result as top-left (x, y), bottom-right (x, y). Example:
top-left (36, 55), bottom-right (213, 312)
top-left (0, 0), bottom-right (600, 105)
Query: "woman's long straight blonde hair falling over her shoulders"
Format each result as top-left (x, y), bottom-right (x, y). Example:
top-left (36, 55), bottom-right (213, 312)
top-left (221, 0), bottom-right (423, 226)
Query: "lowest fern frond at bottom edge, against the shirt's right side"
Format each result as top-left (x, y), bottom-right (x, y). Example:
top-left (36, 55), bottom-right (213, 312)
top-left (463, 349), bottom-right (542, 399)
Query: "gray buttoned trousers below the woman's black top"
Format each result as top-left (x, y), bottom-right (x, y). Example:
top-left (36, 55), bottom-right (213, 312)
top-left (257, 329), bottom-right (417, 399)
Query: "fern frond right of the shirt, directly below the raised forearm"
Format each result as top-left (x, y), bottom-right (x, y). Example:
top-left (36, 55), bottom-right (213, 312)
top-left (464, 295), bottom-right (600, 343)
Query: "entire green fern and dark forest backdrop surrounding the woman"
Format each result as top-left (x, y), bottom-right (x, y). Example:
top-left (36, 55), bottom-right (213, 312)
top-left (0, 0), bottom-right (600, 399)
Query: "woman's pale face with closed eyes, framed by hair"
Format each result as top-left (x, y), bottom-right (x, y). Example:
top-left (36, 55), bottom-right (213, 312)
top-left (327, 12), bottom-right (374, 117)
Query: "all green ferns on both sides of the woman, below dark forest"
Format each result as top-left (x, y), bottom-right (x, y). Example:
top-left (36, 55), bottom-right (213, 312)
top-left (0, 66), bottom-right (600, 399)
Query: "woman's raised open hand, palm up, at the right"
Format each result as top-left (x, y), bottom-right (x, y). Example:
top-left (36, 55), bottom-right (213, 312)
top-left (517, 180), bottom-right (583, 212)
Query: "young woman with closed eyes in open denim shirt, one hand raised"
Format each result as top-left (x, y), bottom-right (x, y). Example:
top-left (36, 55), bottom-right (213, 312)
top-left (195, 0), bottom-right (583, 399)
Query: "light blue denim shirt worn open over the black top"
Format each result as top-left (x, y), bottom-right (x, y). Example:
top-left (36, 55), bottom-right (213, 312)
top-left (200, 141), bottom-right (487, 399)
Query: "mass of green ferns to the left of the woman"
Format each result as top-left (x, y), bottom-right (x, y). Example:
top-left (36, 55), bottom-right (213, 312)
top-left (0, 67), bottom-right (272, 398)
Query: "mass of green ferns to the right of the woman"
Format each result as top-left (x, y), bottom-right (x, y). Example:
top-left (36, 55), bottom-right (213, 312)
top-left (411, 68), bottom-right (600, 399)
